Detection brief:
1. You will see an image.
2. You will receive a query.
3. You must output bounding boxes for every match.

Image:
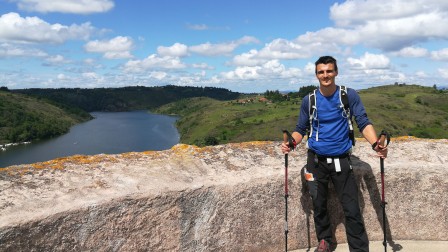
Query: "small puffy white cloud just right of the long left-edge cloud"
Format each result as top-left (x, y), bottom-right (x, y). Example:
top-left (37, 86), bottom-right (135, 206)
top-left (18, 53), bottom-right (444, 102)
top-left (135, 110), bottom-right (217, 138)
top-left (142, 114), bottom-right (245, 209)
top-left (84, 36), bottom-right (134, 59)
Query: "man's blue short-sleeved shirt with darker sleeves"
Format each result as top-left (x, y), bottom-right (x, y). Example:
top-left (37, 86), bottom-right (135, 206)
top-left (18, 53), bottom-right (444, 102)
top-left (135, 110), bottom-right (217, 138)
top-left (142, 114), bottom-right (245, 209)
top-left (295, 86), bottom-right (371, 156)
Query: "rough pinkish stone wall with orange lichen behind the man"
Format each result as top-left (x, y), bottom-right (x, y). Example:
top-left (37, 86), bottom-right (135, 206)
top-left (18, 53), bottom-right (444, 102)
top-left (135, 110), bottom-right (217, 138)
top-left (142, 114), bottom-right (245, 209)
top-left (0, 138), bottom-right (448, 251)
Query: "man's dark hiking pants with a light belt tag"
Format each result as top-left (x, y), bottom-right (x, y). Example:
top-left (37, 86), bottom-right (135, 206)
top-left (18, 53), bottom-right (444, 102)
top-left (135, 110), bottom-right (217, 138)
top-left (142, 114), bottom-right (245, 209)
top-left (304, 150), bottom-right (369, 251)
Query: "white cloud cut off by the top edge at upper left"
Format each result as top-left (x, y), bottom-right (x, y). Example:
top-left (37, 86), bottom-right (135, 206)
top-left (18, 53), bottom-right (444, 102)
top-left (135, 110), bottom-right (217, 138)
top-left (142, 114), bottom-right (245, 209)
top-left (12, 0), bottom-right (115, 14)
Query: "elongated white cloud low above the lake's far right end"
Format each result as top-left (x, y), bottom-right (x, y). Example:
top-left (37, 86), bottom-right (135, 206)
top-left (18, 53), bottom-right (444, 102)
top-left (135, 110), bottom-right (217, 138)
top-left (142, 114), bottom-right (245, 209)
top-left (124, 54), bottom-right (186, 73)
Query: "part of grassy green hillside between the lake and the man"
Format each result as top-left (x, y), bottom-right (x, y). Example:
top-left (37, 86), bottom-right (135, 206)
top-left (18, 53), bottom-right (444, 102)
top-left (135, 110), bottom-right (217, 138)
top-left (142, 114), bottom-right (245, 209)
top-left (156, 97), bottom-right (299, 145)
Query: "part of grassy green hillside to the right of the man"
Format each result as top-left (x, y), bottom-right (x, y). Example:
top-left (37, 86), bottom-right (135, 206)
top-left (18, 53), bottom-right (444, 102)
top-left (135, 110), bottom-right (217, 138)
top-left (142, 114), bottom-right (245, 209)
top-left (359, 85), bottom-right (448, 138)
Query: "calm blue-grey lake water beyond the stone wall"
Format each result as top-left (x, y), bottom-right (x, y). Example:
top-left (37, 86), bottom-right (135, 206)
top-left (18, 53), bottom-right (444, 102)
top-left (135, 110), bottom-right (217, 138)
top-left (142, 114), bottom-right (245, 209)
top-left (0, 111), bottom-right (180, 167)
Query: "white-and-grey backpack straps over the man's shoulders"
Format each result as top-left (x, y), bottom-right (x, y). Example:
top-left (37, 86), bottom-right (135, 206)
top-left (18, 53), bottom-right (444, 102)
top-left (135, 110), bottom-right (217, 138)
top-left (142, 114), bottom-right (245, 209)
top-left (308, 86), bottom-right (355, 146)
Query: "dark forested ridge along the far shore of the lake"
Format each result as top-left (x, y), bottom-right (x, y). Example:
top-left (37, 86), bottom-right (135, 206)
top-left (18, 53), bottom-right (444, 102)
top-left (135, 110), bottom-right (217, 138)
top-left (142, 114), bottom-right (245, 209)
top-left (12, 85), bottom-right (240, 112)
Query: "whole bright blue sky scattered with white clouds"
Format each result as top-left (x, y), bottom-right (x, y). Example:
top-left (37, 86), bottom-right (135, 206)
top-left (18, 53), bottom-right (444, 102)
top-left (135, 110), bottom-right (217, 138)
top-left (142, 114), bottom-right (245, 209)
top-left (0, 0), bottom-right (448, 92)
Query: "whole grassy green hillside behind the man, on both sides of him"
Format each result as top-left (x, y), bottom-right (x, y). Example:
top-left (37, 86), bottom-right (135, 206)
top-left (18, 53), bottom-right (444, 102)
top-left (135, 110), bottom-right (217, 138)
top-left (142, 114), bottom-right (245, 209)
top-left (156, 85), bottom-right (448, 146)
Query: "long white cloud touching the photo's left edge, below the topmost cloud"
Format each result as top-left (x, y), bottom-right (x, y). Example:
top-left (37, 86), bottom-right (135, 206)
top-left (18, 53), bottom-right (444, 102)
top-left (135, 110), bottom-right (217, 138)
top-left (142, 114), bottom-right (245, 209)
top-left (0, 12), bottom-right (94, 43)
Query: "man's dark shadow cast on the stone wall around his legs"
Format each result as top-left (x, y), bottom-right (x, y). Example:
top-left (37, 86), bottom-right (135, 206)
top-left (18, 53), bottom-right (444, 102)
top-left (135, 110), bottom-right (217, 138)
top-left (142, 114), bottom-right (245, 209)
top-left (300, 155), bottom-right (403, 251)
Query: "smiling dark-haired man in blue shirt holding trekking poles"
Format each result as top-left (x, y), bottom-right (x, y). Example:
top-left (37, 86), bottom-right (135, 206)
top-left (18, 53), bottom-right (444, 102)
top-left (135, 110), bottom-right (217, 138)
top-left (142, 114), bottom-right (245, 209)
top-left (281, 56), bottom-right (387, 252)
